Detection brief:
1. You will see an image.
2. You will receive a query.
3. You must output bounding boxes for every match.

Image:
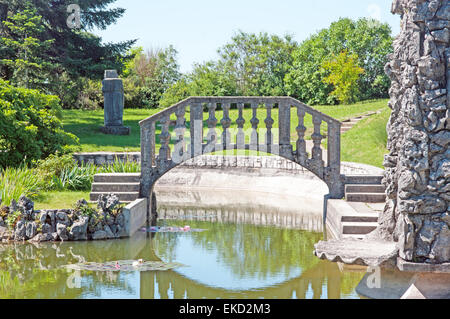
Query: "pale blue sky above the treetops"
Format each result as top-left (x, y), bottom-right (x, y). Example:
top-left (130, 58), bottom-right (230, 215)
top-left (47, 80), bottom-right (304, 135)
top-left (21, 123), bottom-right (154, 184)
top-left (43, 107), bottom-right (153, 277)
top-left (94, 0), bottom-right (400, 73)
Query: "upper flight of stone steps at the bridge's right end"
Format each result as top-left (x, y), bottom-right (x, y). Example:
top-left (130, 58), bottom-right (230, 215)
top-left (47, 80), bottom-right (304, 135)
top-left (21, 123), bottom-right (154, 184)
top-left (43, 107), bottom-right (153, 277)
top-left (345, 175), bottom-right (386, 203)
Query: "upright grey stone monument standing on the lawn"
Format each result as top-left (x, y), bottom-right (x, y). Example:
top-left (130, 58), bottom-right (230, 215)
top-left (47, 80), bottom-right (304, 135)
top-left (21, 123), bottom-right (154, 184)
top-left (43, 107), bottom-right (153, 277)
top-left (101, 70), bottom-right (131, 135)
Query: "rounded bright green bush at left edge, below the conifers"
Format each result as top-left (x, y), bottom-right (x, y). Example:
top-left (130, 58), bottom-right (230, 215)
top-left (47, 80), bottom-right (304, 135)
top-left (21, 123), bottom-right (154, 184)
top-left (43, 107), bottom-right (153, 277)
top-left (0, 80), bottom-right (79, 167)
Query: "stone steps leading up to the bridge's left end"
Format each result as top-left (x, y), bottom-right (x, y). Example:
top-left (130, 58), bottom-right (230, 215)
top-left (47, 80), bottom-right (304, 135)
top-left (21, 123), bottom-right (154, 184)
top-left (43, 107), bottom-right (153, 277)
top-left (90, 173), bottom-right (141, 203)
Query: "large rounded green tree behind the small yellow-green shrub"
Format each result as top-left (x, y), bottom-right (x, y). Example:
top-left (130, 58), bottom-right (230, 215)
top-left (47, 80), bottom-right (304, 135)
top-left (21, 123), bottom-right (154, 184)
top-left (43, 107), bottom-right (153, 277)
top-left (285, 18), bottom-right (392, 105)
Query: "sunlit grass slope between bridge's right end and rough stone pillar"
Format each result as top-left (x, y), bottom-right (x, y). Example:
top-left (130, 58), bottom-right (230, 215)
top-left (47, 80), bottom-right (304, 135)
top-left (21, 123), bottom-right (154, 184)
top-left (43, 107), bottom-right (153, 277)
top-left (341, 108), bottom-right (391, 168)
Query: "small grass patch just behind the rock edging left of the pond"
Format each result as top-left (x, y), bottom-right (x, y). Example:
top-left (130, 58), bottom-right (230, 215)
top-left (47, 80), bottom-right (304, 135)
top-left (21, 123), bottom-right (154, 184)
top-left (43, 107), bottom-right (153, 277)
top-left (34, 191), bottom-right (90, 210)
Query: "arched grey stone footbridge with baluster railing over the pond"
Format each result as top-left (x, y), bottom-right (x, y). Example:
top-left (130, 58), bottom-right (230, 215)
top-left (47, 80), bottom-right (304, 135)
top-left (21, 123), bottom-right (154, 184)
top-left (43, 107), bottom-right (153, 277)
top-left (139, 97), bottom-right (344, 212)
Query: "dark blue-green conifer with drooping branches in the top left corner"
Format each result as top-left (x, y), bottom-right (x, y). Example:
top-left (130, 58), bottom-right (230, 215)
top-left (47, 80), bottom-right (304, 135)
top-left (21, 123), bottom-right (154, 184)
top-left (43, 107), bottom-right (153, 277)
top-left (0, 0), bottom-right (135, 107)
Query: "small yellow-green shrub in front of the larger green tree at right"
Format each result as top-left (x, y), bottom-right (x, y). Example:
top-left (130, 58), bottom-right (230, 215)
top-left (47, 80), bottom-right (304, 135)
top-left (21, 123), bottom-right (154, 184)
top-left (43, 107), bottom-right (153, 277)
top-left (322, 50), bottom-right (364, 104)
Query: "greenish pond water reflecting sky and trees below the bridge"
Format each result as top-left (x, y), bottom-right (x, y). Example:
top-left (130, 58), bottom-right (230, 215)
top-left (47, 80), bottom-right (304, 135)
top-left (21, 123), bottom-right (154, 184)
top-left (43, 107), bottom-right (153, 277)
top-left (0, 207), bottom-right (364, 299)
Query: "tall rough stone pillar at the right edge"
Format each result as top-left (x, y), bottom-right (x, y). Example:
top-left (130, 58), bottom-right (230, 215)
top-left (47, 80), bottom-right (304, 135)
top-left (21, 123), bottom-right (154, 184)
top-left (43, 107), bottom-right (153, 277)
top-left (378, 0), bottom-right (450, 264)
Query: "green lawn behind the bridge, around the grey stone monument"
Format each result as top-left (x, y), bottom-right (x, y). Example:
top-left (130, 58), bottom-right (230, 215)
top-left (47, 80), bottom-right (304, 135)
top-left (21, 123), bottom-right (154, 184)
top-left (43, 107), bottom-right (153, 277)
top-left (63, 100), bottom-right (387, 152)
